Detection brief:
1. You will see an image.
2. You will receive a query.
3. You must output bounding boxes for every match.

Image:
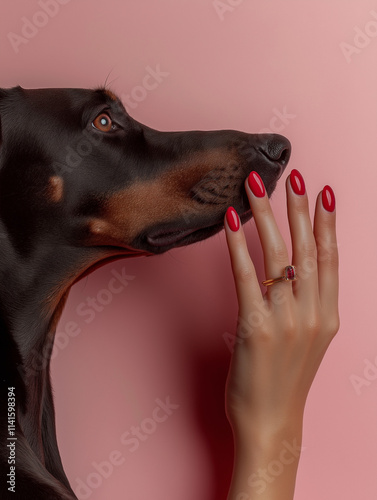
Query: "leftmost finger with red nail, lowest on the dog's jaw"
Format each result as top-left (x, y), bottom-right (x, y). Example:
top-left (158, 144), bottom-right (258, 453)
top-left (224, 207), bottom-right (263, 310)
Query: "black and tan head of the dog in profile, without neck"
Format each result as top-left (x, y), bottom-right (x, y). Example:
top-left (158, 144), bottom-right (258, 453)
top-left (0, 87), bottom-right (290, 264)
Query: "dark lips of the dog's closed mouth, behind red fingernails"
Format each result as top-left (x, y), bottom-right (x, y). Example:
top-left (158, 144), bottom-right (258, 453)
top-left (146, 210), bottom-right (252, 253)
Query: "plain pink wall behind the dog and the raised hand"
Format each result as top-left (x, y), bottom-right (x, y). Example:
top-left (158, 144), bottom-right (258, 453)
top-left (0, 0), bottom-right (377, 500)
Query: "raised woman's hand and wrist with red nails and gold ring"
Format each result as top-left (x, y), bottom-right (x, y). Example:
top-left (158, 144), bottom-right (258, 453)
top-left (225, 170), bottom-right (339, 500)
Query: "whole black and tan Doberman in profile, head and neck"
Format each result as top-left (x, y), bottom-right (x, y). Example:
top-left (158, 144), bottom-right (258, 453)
top-left (0, 87), bottom-right (291, 500)
